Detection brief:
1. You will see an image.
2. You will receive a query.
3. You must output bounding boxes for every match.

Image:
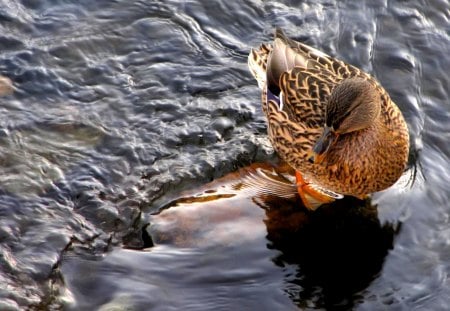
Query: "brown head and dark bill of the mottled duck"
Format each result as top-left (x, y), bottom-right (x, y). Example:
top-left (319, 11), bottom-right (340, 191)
top-left (310, 78), bottom-right (381, 164)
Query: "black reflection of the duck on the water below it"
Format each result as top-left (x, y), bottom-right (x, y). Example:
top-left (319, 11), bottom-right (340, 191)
top-left (266, 197), bottom-right (396, 310)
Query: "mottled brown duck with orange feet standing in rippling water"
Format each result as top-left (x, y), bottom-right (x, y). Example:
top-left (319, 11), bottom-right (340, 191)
top-left (248, 29), bottom-right (409, 210)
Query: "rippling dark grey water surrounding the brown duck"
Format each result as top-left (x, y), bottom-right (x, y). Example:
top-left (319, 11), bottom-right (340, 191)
top-left (0, 0), bottom-right (450, 310)
